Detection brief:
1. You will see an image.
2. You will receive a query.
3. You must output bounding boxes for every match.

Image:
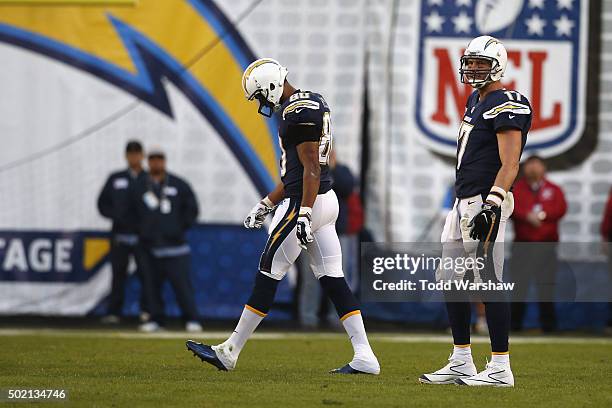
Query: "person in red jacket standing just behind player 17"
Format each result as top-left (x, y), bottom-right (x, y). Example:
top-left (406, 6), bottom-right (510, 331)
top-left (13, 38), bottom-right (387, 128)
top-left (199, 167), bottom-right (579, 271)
top-left (511, 156), bottom-right (567, 332)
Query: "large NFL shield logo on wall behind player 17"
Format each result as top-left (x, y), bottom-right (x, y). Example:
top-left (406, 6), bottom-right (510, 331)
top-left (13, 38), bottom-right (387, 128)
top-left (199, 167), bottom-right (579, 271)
top-left (415, 0), bottom-right (599, 163)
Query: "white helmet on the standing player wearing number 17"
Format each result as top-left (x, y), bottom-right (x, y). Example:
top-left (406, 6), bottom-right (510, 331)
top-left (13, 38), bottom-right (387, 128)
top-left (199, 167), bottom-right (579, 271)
top-left (459, 35), bottom-right (508, 89)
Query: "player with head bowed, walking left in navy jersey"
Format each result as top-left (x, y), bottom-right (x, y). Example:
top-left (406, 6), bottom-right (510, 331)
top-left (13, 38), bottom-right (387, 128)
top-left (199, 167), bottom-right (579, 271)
top-left (187, 58), bottom-right (380, 374)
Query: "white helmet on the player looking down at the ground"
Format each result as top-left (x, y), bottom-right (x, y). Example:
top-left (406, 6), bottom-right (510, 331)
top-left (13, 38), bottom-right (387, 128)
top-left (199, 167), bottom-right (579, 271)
top-left (242, 58), bottom-right (288, 117)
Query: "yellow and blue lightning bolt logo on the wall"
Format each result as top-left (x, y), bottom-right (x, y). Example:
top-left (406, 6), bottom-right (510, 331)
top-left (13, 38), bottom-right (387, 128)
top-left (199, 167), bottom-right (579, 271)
top-left (0, 0), bottom-right (278, 194)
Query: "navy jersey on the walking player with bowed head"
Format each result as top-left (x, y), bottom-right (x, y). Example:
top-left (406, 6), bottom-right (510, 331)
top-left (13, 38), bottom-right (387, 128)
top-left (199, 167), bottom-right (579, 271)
top-left (278, 90), bottom-right (332, 197)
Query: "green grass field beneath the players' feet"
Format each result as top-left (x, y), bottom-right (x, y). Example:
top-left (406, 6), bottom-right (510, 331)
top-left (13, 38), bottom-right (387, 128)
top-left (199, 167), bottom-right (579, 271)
top-left (0, 332), bottom-right (612, 408)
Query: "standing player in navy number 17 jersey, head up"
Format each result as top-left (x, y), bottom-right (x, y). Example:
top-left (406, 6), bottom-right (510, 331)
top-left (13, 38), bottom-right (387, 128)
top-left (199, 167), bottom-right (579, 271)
top-left (419, 36), bottom-right (532, 387)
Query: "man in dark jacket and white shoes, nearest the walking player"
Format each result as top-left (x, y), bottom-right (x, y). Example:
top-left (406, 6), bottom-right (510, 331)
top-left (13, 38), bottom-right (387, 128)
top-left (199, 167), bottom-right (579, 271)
top-left (130, 148), bottom-right (202, 332)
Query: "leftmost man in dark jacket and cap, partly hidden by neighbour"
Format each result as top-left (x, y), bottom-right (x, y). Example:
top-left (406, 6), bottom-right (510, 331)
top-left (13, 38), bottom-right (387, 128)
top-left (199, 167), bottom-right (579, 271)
top-left (98, 140), bottom-right (146, 323)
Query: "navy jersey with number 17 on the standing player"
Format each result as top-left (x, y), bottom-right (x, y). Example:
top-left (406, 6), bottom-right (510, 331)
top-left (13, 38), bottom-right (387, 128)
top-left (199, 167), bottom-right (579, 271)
top-left (455, 89), bottom-right (532, 198)
